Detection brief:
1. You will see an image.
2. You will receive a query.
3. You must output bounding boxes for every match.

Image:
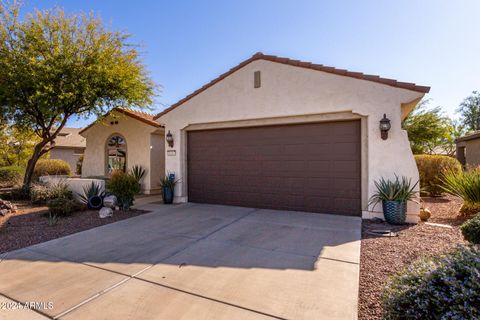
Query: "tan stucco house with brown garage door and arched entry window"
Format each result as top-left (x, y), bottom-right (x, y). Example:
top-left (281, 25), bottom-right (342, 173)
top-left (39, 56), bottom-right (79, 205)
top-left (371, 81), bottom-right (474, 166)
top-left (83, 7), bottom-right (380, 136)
top-left (82, 53), bottom-right (429, 222)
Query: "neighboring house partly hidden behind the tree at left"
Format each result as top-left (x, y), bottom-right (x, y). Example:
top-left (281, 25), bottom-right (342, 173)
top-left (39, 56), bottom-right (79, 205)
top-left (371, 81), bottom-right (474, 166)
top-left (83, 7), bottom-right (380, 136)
top-left (50, 128), bottom-right (86, 173)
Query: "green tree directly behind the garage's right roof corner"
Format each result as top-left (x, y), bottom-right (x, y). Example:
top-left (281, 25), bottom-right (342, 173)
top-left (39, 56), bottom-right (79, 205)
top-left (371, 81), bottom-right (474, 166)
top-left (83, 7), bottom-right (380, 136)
top-left (402, 100), bottom-right (452, 154)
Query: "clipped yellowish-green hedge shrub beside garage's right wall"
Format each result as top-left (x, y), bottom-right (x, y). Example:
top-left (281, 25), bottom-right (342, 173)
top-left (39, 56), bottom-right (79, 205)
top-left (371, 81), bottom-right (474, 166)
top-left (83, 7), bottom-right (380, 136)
top-left (415, 154), bottom-right (462, 197)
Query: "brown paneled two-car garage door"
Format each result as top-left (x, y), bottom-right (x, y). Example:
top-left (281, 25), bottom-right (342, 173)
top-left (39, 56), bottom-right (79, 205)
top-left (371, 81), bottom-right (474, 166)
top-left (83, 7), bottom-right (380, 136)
top-left (187, 121), bottom-right (361, 215)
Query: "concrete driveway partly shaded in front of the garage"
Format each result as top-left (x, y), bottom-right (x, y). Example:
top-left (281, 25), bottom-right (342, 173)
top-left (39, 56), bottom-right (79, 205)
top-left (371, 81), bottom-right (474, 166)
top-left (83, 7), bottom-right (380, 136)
top-left (0, 204), bottom-right (361, 320)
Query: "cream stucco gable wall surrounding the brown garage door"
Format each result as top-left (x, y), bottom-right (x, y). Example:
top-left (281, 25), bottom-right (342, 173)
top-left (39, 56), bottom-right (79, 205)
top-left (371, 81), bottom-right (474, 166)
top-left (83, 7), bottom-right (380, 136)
top-left (158, 60), bottom-right (423, 222)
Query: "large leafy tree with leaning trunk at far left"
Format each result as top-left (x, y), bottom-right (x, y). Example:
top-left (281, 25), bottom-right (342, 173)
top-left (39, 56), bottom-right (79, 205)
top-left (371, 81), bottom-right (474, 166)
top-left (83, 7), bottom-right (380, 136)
top-left (0, 2), bottom-right (155, 188)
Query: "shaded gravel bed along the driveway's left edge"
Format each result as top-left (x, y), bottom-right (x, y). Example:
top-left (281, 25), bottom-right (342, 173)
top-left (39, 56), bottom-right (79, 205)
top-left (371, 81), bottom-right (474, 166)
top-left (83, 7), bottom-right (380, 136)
top-left (0, 201), bottom-right (147, 254)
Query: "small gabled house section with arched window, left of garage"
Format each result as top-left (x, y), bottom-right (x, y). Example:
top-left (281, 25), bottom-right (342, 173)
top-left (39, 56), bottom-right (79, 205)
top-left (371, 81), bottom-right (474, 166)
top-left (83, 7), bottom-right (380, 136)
top-left (80, 109), bottom-right (165, 194)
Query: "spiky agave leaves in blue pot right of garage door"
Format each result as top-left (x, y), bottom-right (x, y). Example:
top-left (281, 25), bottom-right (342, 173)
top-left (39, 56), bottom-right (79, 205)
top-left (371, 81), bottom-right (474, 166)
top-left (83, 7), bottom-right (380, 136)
top-left (368, 175), bottom-right (418, 206)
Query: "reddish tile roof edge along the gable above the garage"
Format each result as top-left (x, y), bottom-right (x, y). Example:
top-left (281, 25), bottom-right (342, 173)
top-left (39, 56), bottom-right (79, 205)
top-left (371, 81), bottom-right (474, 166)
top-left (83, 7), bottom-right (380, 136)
top-left (154, 52), bottom-right (430, 119)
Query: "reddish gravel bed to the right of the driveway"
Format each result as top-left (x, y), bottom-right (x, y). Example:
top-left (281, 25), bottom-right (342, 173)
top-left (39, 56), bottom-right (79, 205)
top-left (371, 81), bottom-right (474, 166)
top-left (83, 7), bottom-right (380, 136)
top-left (358, 196), bottom-right (464, 320)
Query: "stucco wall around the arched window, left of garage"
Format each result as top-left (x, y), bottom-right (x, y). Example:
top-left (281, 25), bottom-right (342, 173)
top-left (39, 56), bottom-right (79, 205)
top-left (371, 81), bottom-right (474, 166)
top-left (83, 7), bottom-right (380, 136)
top-left (82, 113), bottom-right (163, 193)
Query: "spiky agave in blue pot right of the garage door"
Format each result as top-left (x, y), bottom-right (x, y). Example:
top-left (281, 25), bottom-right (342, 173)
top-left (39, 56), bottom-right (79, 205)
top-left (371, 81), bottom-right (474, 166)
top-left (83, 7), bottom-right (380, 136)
top-left (368, 175), bottom-right (418, 224)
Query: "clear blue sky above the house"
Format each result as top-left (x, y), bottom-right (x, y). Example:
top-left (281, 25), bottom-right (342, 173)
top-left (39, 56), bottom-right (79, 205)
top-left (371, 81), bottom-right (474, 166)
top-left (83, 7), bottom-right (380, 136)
top-left (20, 0), bottom-right (480, 127)
